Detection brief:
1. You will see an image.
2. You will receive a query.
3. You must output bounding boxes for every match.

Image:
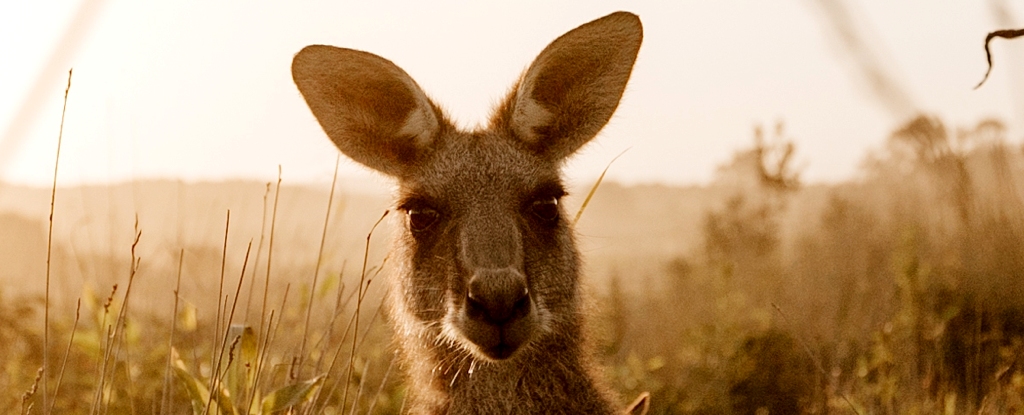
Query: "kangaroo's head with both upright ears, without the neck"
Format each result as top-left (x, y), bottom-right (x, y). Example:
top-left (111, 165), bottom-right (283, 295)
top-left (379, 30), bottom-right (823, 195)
top-left (292, 12), bottom-right (642, 361)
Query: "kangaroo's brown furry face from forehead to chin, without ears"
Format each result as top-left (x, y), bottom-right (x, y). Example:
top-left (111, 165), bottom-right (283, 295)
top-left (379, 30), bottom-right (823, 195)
top-left (398, 131), bottom-right (578, 359)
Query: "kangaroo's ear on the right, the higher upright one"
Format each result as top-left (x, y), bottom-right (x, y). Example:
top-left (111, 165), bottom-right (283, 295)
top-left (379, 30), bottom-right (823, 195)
top-left (495, 11), bottom-right (643, 161)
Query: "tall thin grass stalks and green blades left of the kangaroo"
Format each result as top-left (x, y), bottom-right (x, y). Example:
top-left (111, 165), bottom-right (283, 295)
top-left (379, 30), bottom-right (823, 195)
top-left (14, 68), bottom-right (401, 414)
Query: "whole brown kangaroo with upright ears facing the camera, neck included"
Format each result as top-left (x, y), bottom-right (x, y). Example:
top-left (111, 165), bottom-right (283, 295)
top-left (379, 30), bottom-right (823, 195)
top-left (292, 11), bottom-right (647, 414)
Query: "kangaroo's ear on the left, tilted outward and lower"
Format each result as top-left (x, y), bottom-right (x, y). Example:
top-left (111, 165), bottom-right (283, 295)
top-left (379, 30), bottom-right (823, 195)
top-left (292, 45), bottom-right (441, 176)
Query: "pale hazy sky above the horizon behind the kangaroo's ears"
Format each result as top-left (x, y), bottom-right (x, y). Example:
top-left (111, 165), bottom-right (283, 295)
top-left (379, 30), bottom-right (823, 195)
top-left (0, 0), bottom-right (1024, 185)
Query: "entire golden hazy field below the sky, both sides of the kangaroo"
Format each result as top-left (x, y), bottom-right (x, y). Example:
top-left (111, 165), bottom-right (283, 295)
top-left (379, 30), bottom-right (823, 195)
top-left (0, 116), bottom-right (1024, 414)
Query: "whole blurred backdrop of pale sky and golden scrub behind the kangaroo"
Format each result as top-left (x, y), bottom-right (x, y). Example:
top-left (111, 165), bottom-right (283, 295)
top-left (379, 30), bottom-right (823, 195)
top-left (0, 0), bottom-right (1024, 414)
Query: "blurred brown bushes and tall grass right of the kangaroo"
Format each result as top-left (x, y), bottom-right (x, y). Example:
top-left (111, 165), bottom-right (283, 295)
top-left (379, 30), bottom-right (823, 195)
top-left (608, 117), bottom-right (1024, 414)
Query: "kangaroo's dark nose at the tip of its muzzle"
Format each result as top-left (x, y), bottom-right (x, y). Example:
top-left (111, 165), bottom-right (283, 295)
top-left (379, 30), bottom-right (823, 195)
top-left (466, 268), bottom-right (530, 326)
